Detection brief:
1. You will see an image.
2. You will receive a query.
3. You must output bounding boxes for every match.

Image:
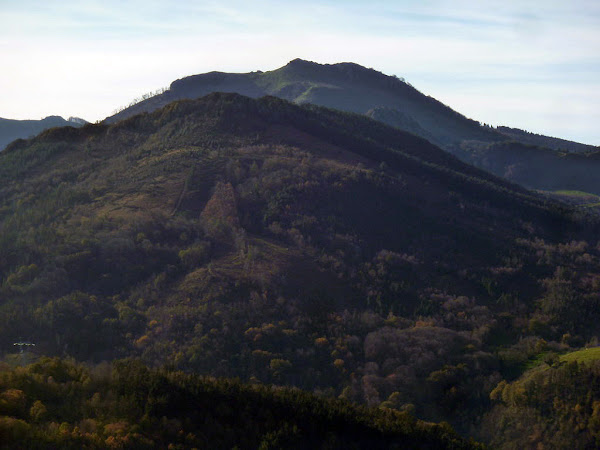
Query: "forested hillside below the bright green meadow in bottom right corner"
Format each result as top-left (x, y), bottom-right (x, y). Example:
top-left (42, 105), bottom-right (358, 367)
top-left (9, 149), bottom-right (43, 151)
top-left (483, 356), bottom-right (600, 449)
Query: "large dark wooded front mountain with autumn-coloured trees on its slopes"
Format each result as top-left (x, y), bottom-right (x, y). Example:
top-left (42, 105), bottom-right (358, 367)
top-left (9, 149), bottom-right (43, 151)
top-left (0, 93), bottom-right (600, 446)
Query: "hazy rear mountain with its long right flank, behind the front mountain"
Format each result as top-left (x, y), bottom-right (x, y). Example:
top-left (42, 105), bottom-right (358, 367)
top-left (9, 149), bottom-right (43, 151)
top-left (106, 59), bottom-right (600, 194)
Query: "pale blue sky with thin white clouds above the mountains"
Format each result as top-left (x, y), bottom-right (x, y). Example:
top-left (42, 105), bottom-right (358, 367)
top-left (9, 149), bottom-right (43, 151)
top-left (0, 0), bottom-right (600, 145)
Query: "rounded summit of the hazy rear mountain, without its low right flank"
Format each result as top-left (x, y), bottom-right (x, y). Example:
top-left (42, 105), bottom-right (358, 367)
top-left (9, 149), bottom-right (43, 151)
top-left (107, 59), bottom-right (496, 149)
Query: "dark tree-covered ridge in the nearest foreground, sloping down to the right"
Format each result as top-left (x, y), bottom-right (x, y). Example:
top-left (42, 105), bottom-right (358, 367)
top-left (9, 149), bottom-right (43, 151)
top-left (0, 358), bottom-right (481, 450)
